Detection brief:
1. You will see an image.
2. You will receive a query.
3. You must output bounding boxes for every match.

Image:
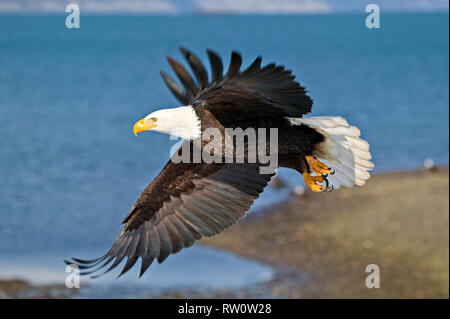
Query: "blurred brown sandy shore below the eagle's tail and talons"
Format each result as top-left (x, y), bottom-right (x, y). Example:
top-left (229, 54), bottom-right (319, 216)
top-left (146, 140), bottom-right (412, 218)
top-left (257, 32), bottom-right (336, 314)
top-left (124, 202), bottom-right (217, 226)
top-left (201, 168), bottom-right (449, 298)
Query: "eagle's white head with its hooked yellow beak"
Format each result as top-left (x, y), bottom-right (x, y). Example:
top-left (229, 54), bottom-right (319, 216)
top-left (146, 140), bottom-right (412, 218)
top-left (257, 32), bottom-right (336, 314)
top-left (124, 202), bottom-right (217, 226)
top-left (133, 105), bottom-right (201, 140)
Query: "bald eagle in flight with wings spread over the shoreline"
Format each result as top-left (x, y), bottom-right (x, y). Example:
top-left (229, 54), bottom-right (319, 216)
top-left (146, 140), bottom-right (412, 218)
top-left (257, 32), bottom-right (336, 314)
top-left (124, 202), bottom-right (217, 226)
top-left (65, 48), bottom-right (373, 277)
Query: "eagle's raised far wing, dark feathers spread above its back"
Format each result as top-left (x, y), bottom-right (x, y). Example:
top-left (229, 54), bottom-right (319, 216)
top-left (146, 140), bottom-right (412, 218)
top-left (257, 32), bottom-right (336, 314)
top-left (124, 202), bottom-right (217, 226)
top-left (161, 48), bottom-right (313, 117)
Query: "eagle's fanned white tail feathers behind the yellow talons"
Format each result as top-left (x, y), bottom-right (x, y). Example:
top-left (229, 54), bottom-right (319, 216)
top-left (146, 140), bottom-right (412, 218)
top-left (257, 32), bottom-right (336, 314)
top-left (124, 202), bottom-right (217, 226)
top-left (289, 116), bottom-right (374, 188)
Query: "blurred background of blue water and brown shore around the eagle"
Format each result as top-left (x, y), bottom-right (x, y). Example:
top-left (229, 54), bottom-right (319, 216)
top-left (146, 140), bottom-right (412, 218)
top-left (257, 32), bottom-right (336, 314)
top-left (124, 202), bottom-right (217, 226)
top-left (0, 0), bottom-right (449, 298)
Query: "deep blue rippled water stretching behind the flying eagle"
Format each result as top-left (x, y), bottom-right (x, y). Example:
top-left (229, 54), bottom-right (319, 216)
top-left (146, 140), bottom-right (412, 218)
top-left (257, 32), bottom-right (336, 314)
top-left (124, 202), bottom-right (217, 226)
top-left (0, 14), bottom-right (449, 292)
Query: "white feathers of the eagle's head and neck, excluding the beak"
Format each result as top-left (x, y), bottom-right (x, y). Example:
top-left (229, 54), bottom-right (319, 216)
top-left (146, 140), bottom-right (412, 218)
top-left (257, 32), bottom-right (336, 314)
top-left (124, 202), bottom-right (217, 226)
top-left (149, 105), bottom-right (201, 140)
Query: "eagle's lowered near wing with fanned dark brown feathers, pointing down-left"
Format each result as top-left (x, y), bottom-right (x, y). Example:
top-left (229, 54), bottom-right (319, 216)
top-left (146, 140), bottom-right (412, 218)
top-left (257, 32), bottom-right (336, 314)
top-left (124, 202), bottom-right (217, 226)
top-left (65, 146), bottom-right (272, 277)
